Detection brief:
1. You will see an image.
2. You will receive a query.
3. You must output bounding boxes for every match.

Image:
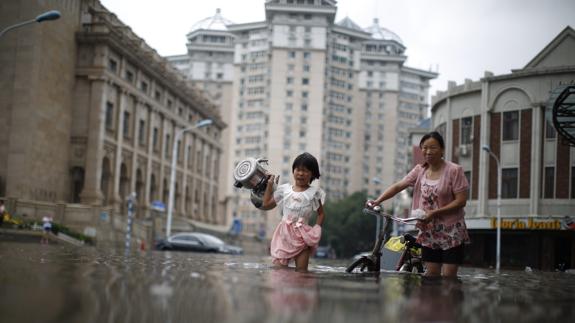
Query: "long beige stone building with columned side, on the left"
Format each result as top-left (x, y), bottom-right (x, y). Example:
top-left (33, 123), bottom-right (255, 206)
top-left (0, 0), bottom-right (226, 232)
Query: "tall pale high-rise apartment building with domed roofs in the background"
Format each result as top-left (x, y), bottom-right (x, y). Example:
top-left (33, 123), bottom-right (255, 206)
top-left (168, 0), bottom-right (437, 238)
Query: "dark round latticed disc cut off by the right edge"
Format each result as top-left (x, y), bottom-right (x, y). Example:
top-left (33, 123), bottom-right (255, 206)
top-left (552, 85), bottom-right (575, 146)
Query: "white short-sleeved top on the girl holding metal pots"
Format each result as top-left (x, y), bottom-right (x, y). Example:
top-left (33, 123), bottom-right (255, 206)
top-left (274, 184), bottom-right (325, 225)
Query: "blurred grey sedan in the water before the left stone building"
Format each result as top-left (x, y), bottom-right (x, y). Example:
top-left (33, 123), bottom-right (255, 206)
top-left (156, 232), bottom-right (244, 255)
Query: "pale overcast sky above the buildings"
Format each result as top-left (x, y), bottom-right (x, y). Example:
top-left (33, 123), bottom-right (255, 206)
top-left (101, 0), bottom-right (575, 94)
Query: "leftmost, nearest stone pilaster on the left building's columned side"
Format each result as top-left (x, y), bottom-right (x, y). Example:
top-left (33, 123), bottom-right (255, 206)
top-left (80, 77), bottom-right (107, 205)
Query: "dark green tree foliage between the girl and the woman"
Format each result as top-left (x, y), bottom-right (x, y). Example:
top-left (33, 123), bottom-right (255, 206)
top-left (320, 192), bottom-right (376, 258)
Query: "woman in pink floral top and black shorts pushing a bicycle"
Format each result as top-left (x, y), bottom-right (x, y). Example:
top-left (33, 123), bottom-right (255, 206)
top-left (367, 131), bottom-right (469, 277)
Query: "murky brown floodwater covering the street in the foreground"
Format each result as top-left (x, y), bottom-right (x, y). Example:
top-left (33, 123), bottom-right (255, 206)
top-left (0, 234), bottom-right (575, 323)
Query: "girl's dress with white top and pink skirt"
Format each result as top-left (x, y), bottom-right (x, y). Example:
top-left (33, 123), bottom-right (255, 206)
top-left (270, 184), bottom-right (325, 266)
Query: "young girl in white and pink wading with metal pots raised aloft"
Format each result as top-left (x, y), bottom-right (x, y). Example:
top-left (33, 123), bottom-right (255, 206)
top-left (262, 153), bottom-right (325, 272)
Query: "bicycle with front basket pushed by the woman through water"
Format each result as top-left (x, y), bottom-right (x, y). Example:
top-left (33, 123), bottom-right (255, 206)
top-left (345, 206), bottom-right (424, 273)
